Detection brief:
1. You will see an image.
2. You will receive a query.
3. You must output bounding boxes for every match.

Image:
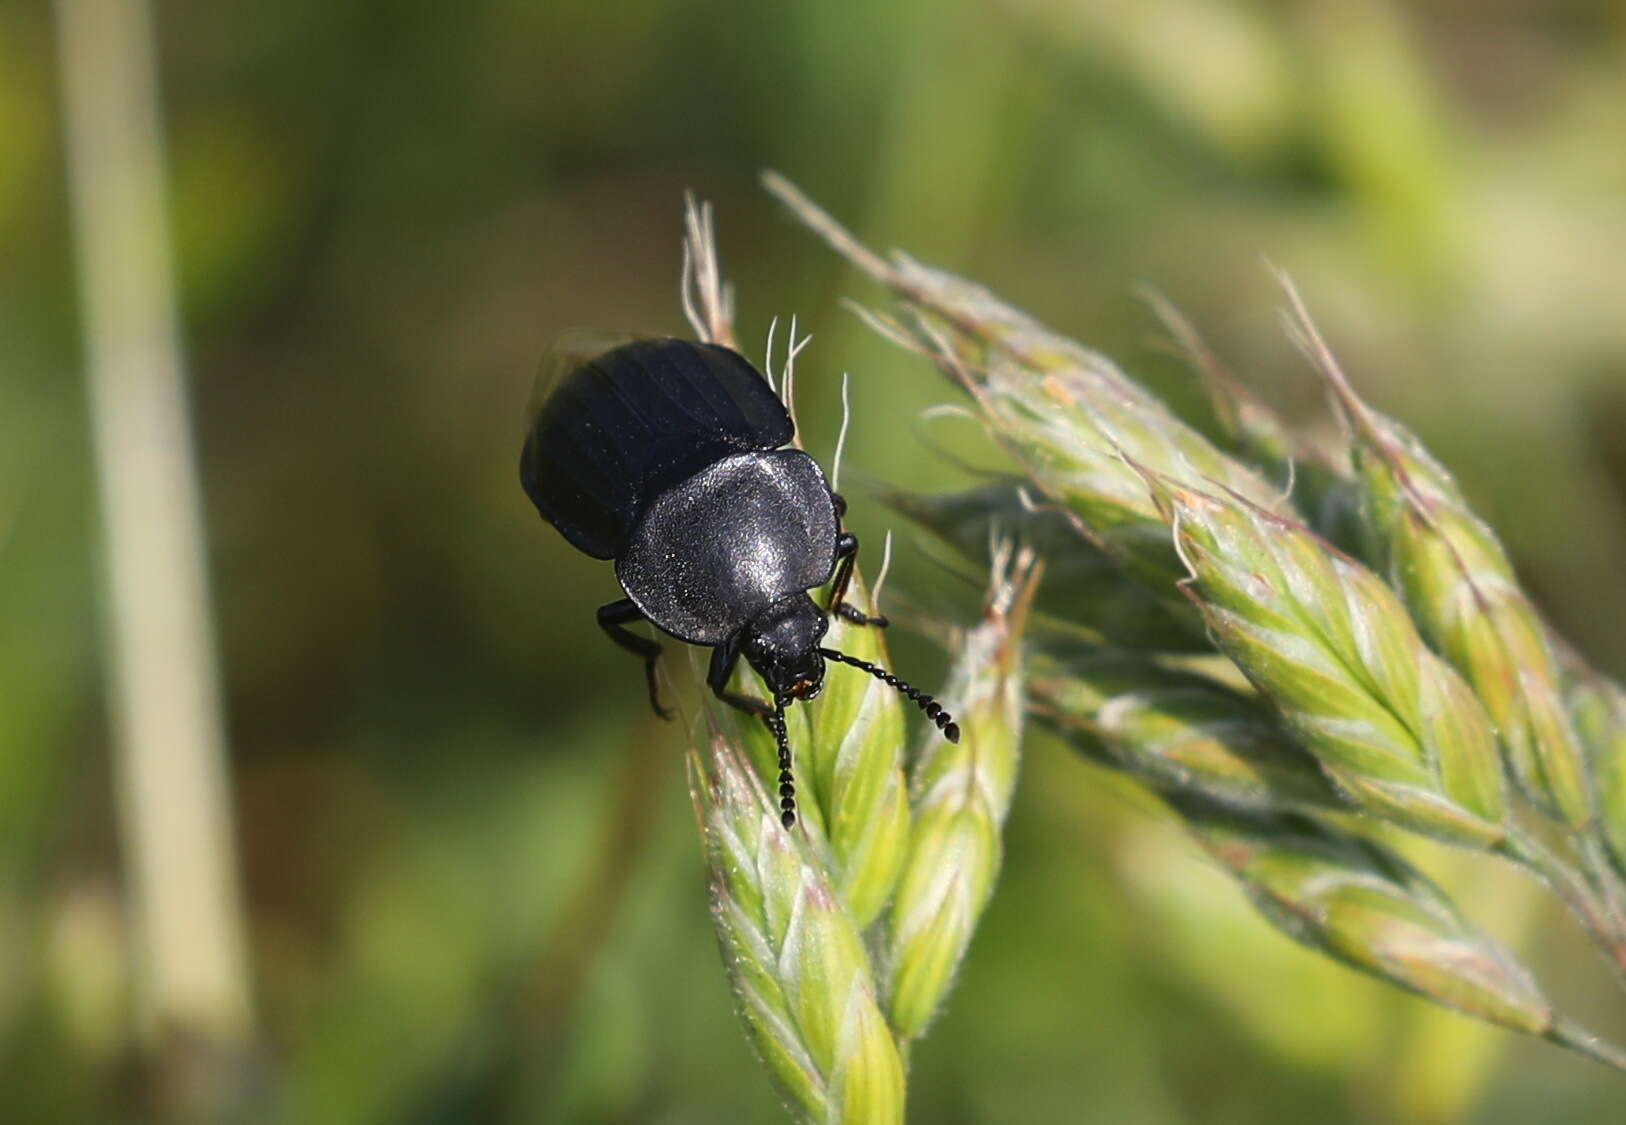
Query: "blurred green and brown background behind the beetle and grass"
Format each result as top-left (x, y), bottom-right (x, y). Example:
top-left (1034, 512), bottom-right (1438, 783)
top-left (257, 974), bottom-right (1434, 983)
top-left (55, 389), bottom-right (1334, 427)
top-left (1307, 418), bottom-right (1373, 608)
top-left (9, 0), bottom-right (1626, 1125)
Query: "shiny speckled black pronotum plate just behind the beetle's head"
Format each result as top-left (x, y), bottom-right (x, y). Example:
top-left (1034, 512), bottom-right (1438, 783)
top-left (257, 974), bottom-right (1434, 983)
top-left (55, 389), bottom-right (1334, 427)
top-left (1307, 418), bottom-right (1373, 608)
top-left (615, 449), bottom-right (839, 645)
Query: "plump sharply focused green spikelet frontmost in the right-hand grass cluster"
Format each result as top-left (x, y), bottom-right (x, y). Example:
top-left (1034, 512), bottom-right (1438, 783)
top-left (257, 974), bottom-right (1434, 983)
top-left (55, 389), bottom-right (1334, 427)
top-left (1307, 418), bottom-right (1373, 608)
top-left (1146, 473), bottom-right (1504, 847)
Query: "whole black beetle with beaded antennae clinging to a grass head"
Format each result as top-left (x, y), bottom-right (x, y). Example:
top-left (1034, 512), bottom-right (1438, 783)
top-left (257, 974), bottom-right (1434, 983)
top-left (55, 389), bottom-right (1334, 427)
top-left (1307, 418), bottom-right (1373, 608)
top-left (520, 338), bottom-right (959, 827)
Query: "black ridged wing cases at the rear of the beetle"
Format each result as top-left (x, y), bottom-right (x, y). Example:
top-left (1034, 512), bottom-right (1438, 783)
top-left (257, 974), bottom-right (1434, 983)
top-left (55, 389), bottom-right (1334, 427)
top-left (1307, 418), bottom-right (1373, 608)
top-left (520, 340), bottom-right (793, 559)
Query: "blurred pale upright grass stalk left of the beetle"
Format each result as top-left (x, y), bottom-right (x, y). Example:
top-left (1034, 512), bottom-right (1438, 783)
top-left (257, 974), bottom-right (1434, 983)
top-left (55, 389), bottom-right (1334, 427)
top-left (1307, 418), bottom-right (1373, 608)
top-left (57, 0), bottom-right (254, 1049)
